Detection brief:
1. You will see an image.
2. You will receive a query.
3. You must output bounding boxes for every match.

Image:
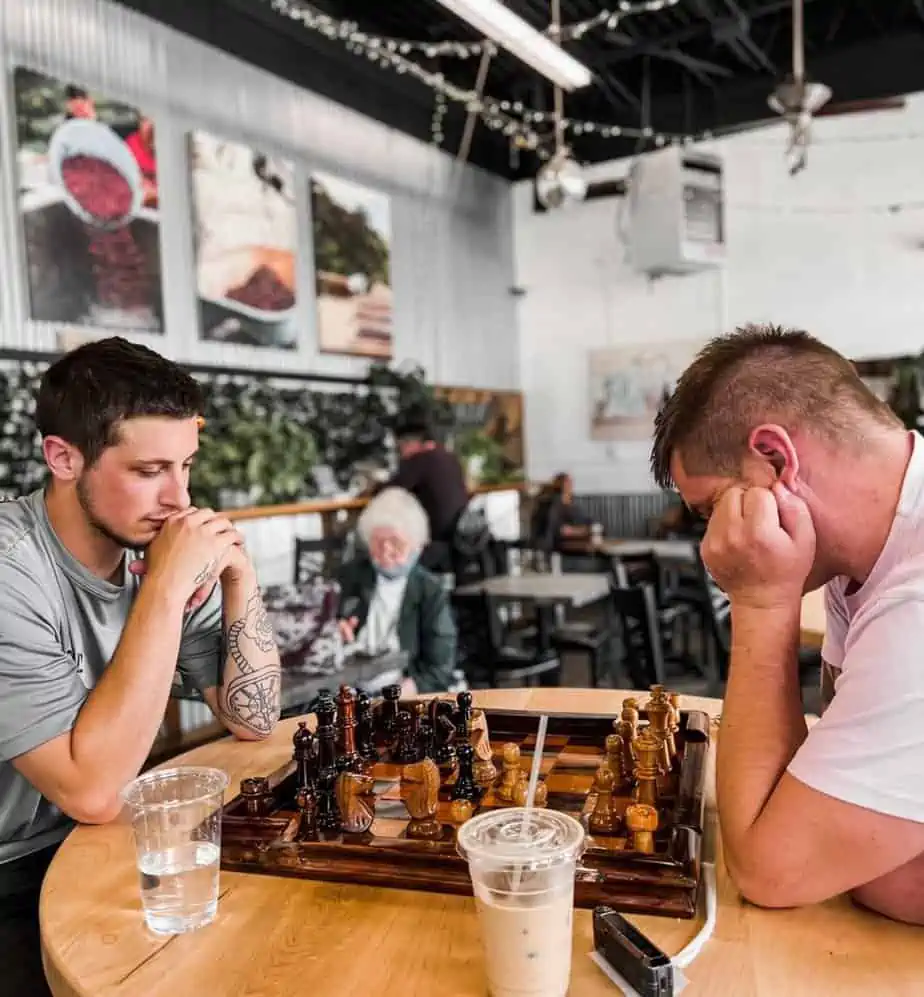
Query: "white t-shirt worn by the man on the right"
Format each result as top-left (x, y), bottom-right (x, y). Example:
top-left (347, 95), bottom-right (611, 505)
top-left (789, 433), bottom-right (924, 823)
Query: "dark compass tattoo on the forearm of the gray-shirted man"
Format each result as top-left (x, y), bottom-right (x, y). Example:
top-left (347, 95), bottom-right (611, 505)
top-left (220, 589), bottom-right (280, 735)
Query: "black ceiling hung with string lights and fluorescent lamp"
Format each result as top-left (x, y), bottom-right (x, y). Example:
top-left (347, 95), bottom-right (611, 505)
top-left (121, 0), bottom-right (924, 178)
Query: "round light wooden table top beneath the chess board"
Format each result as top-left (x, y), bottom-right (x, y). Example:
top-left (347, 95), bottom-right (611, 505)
top-left (41, 689), bottom-right (924, 997)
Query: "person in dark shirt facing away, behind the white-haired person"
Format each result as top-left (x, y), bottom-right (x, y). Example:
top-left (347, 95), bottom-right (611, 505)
top-left (390, 412), bottom-right (469, 574)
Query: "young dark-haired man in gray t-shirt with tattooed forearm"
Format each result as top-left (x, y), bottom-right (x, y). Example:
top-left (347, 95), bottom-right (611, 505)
top-left (0, 338), bottom-right (279, 994)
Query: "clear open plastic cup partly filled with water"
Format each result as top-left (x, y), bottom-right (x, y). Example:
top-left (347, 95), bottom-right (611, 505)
top-left (122, 766), bottom-right (228, 935)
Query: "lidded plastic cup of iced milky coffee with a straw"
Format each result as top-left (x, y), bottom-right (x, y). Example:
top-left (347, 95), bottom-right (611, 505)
top-left (457, 807), bottom-right (584, 997)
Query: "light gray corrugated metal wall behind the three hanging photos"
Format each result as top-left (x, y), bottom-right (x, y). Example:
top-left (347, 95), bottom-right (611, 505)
top-left (0, 0), bottom-right (519, 388)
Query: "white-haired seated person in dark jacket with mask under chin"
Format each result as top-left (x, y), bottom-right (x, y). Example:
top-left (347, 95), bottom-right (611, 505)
top-left (338, 488), bottom-right (456, 696)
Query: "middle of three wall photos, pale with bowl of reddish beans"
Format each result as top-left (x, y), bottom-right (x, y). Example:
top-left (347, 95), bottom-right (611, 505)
top-left (189, 132), bottom-right (298, 350)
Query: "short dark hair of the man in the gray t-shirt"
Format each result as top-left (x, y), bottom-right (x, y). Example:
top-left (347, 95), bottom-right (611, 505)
top-left (35, 336), bottom-right (204, 466)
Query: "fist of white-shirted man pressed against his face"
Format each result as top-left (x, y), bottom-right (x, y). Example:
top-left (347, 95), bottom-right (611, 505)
top-left (702, 481), bottom-right (815, 610)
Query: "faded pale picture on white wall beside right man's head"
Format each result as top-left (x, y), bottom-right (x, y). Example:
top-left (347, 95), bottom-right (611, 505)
top-left (589, 340), bottom-right (703, 442)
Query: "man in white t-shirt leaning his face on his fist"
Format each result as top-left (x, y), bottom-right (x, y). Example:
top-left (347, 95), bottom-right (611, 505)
top-left (652, 327), bottom-right (924, 923)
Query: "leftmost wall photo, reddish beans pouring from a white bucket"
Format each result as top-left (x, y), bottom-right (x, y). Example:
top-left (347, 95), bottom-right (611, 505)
top-left (13, 67), bottom-right (164, 332)
